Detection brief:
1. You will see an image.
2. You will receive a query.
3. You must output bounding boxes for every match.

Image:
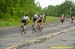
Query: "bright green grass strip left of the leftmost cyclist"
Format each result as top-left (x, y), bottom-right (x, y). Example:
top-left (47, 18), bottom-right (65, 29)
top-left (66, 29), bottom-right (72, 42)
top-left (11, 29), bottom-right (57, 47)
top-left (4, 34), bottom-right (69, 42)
top-left (0, 19), bottom-right (20, 27)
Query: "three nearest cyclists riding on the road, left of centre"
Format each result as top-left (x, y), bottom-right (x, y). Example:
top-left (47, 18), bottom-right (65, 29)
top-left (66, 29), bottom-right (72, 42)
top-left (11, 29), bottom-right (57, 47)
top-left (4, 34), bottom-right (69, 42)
top-left (21, 14), bottom-right (46, 33)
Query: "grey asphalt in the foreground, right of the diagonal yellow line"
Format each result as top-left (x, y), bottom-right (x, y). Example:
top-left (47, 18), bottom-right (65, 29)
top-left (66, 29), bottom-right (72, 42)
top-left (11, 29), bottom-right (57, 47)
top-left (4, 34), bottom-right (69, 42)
top-left (22, 28), bottom-right (75, 49)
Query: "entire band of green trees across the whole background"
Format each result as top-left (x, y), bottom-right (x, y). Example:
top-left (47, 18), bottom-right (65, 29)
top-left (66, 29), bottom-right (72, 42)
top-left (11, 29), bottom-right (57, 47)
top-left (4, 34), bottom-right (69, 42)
top-left (0, 0), bottom-right (75, 19)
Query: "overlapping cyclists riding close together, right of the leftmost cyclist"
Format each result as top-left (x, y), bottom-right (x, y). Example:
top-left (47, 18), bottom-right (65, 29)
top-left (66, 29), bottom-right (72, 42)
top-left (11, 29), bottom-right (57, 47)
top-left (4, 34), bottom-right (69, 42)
top-left (32, 14), bottom-right (46, 32)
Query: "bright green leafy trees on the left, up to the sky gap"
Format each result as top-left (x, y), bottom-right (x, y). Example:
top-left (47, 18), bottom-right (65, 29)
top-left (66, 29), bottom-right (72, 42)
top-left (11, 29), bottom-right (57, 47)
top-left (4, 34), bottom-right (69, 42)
top-left (0, 0), bottom-right (41, 19)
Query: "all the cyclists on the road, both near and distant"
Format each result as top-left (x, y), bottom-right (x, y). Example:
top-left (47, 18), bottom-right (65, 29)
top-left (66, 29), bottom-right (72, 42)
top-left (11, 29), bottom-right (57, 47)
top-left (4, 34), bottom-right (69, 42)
top-left (21, 14), bottom-right (75, 33)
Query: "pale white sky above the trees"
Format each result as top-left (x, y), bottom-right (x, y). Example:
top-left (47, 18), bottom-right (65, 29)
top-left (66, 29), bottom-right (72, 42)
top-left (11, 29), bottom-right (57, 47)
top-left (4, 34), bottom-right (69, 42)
top-left (35, 0), bottom-right (65, 8)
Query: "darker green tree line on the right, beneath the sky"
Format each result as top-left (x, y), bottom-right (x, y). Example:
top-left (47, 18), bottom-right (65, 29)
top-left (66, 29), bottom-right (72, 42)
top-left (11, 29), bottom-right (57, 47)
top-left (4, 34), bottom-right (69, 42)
top-left (43, 1), bottom-right (75, 17)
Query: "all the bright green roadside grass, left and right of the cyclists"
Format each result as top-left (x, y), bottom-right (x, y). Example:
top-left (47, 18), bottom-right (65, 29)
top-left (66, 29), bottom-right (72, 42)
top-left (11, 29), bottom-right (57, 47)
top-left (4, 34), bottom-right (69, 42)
top-left (0, 16), bottom-right (58, 27)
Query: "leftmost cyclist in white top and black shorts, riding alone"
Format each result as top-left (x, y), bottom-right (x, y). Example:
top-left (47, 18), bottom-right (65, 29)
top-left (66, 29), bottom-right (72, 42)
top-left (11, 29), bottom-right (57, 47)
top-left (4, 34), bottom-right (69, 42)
top-left (21, 14), bottom-right (29, 33)
